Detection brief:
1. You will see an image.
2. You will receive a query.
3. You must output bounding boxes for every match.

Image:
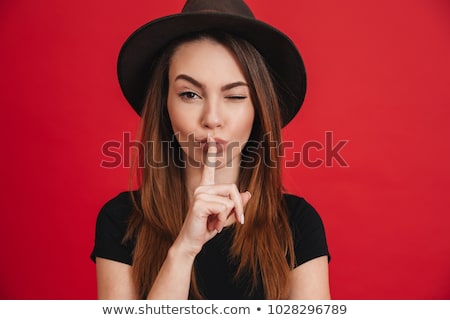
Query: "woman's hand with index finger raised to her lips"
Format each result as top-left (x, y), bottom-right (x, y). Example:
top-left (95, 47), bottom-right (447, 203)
top-left (175, 143), bottom-right (251, 256)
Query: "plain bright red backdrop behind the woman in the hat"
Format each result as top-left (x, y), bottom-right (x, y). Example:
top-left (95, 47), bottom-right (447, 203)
top-left (0, 0), bottom-right (450, 299)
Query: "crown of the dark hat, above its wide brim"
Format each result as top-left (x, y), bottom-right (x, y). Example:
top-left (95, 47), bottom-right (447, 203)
top-left (182, 0), bottom-right (255, 18)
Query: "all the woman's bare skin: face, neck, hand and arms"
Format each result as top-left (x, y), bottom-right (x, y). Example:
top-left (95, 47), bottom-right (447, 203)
top-left (96, 40), bottom-right (330, 300)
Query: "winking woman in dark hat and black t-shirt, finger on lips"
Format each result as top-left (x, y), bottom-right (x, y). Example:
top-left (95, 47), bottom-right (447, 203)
top-left (92, 0), bottom-right (330, 299)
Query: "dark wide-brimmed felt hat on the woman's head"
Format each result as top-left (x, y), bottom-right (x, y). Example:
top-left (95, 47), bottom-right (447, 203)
top-left (117, 0), bottom-right (306, 126)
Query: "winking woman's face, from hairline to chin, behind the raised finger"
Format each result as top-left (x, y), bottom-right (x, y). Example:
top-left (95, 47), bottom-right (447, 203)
top-left (167, 39), bottom-right (254, 167)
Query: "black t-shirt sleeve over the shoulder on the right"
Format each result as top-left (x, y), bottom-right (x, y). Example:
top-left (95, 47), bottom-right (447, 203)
top-left (284, 194), bottom-right (330, 265)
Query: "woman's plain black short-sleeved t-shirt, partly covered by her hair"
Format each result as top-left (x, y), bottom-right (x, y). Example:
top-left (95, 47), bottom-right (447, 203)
top-left (91, 192), bottom-right (330, 300)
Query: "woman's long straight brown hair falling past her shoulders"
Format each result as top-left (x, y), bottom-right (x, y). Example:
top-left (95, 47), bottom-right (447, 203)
top-left (126, 32), bottom-right (295, 299)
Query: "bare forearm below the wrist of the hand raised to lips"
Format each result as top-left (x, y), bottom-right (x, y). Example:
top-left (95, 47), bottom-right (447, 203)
top-left (147, 244), bottom-right (195, 300)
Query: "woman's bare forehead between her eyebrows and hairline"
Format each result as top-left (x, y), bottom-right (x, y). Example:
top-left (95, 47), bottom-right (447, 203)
top-left (169, 39), bottom-right (244, 83)
